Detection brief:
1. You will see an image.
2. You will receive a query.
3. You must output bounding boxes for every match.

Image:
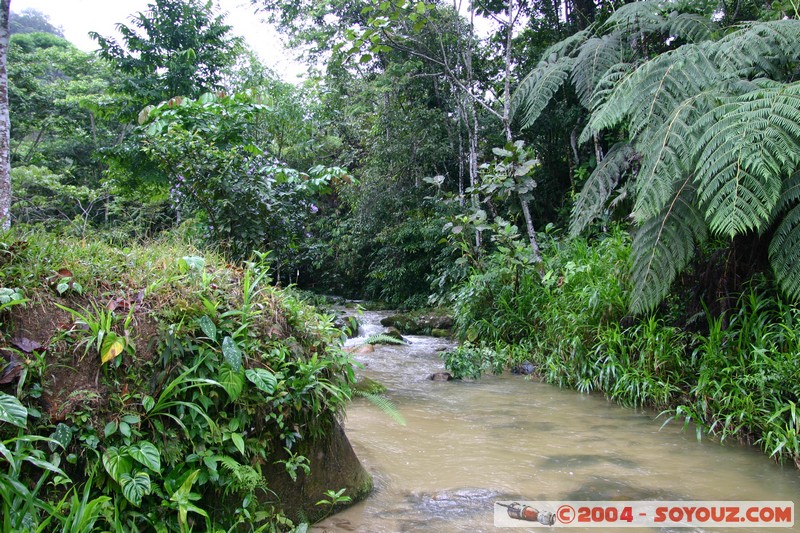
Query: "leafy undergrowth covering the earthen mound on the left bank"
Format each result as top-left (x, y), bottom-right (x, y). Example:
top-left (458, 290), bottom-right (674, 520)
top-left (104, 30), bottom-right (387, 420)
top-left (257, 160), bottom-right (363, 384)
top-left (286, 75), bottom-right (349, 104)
top-left (0, 228), bottom-right (354, 531)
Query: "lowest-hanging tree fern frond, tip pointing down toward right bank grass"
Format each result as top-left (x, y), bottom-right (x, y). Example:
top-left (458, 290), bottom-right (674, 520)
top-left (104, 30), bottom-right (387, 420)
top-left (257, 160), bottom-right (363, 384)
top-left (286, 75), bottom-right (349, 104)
top-left (631, 177), bottom-right (708, 313)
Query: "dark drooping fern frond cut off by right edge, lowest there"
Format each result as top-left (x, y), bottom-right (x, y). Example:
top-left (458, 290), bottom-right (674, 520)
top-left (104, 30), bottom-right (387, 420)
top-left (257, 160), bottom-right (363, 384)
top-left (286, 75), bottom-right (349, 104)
top-left (769, 172), bottom-right (800, 300)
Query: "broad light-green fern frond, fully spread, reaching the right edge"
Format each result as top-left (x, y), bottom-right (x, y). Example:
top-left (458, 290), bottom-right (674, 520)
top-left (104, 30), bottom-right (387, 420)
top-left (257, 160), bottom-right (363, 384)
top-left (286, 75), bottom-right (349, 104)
top-left (696, 83), bottom-right (800, 237)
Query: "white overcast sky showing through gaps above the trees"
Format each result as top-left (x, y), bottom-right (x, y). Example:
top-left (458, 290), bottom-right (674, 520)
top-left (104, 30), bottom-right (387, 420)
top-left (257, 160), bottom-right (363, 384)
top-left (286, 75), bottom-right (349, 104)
top-left (11, 0), bottom-right (305, 82)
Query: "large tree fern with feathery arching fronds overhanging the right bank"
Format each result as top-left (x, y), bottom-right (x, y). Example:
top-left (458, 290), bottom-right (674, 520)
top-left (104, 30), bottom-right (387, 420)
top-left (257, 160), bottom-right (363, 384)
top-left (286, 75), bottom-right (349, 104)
top-left (517, 1), bottom-right (800, 311)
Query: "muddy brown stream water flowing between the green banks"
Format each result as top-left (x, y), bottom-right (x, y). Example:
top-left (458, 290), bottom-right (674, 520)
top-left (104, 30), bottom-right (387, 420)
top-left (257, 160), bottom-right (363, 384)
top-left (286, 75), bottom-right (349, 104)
top-left (313, 312), bottom-right (800, 533)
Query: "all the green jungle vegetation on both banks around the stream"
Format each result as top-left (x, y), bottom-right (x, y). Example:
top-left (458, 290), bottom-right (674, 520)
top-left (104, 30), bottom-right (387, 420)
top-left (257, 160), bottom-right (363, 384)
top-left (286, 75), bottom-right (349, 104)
top-left (0, 0), bottom-right (800, 531)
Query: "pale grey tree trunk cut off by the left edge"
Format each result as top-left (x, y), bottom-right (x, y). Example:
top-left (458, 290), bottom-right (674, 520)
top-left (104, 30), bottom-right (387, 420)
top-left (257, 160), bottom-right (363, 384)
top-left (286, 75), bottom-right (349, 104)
top-left (0, 0), bottom-right (11, 230)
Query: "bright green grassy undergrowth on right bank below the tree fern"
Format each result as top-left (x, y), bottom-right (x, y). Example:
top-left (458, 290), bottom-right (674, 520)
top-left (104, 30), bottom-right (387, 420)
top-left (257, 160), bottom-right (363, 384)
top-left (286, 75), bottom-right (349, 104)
top-left (444, 228), bottom-right (800, 468)
